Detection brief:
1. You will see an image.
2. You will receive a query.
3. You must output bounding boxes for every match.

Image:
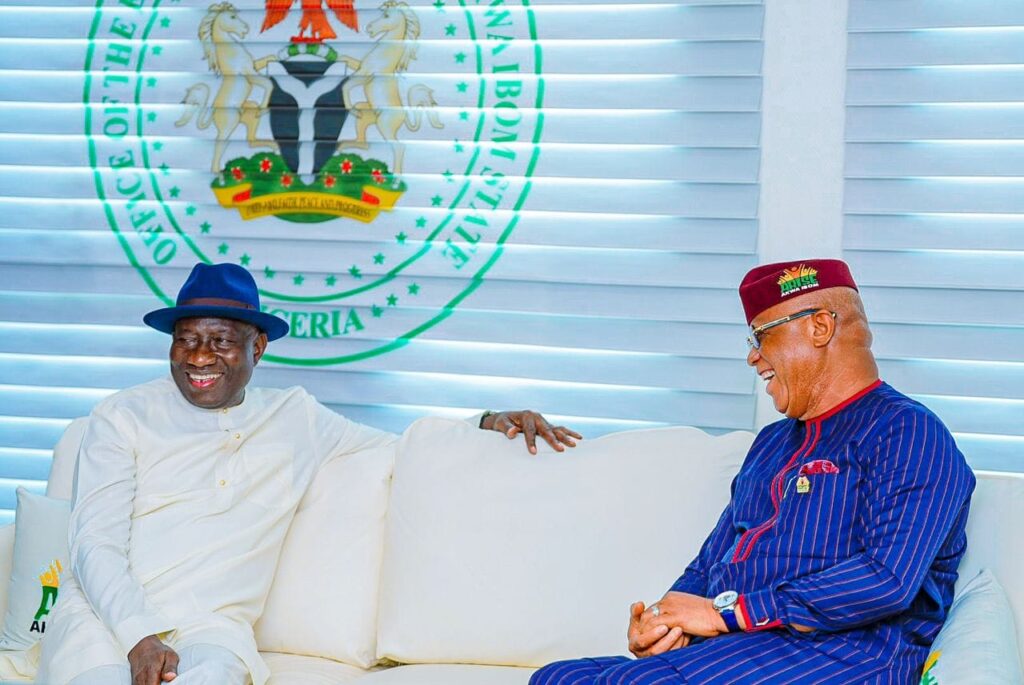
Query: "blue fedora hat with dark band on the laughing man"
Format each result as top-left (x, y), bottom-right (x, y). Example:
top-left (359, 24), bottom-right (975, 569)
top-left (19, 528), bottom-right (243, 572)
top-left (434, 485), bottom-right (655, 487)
top-left (142, 263), bottom-right (288, 340)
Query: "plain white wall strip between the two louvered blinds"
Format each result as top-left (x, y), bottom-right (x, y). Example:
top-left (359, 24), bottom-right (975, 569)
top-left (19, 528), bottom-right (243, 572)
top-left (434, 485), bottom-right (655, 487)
top-left (756, 0), bottom-right (848, 427)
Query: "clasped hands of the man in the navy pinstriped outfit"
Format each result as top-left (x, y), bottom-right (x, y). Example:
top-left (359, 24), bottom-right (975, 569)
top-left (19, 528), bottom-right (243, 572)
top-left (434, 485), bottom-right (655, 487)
top-left (627, 592), bottom-right (729, 658)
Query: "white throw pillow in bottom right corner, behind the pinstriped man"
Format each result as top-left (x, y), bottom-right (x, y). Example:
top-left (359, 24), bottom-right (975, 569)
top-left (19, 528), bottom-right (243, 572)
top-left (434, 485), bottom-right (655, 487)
top-left (921, 569), bottom-right (1024, 685)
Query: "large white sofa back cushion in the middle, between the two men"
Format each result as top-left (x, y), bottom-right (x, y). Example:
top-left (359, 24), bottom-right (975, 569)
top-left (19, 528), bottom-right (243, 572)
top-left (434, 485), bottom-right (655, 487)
top-left (378, 419), bottom-right (753, 666)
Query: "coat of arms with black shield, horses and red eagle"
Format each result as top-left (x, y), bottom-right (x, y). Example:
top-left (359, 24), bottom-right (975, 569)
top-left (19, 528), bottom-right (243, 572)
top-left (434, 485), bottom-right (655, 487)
top-left (175, 0), bottom-right (443, 222)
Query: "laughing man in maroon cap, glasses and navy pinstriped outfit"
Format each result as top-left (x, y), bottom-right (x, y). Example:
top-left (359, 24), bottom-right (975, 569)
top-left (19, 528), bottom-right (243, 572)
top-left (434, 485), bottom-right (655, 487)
top-left (530, 259), bottom-right (975, 685)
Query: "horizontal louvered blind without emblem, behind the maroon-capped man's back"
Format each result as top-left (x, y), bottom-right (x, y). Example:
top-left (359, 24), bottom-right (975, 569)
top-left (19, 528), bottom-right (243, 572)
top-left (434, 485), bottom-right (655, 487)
top-left (844, 0), bottom-right (1024, 471)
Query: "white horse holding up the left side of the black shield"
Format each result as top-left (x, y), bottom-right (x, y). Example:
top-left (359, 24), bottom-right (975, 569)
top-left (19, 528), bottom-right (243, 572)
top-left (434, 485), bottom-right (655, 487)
top-left (174, 2), bottom-right (278, 172)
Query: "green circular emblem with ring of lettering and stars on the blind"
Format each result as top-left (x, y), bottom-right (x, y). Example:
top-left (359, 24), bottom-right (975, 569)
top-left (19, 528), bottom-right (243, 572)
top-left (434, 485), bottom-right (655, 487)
top-left (83, 0), bottom-right (544, 366)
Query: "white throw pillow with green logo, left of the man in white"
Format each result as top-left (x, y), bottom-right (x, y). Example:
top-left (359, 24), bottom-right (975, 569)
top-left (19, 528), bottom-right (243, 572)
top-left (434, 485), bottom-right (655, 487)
top-left (0, 487), bottom-right (71, 649)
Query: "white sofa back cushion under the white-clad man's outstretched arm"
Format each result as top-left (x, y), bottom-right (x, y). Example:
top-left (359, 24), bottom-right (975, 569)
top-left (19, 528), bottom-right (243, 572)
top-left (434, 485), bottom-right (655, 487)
top-left (256, 445), bottom-right (394, 668)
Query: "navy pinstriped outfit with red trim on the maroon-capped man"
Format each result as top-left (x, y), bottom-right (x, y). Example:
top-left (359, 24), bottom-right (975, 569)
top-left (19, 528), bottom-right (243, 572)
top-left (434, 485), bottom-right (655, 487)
top-left (530, 381), bottom-right (975, 685)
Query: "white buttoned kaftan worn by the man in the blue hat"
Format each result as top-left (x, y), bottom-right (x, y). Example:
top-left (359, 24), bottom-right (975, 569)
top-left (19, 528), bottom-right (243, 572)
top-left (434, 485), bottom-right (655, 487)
top-left (39, 377), bottom-right (396, 685)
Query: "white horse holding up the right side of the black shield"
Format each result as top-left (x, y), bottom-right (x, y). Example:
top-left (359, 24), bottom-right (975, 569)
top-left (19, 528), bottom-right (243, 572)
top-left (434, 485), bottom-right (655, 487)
top-left (338, 0), bottom-right (443, 176)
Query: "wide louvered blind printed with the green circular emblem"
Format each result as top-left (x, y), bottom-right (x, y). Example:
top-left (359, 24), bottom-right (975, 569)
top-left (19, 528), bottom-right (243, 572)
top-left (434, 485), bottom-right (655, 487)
top-left (0, 0), bottom-right (763, 518)
